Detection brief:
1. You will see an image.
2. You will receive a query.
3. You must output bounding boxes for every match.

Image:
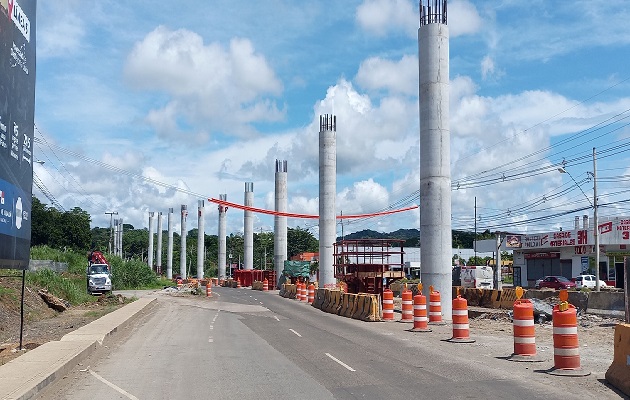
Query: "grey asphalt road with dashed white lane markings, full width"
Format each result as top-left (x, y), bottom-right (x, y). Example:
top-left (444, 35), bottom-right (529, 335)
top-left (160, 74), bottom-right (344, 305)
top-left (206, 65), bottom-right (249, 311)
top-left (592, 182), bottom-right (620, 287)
top-left (39, 287), bottom-right (619, 400)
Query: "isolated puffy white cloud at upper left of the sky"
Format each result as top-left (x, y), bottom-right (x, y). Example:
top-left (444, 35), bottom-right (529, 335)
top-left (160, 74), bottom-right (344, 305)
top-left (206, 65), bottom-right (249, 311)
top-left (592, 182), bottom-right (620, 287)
top-left (125, 26), bottom-right (284, 139)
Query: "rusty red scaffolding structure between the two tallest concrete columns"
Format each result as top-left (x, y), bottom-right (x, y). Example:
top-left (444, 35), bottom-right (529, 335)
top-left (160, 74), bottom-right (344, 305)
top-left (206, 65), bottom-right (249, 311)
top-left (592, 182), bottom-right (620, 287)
top-left (334, 239), bottom-right (405, 295)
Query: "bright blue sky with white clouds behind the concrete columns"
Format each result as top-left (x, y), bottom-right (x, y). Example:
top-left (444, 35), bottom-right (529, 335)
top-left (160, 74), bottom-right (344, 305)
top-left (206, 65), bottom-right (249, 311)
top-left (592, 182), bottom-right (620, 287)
top-left (33, 0), bottom-right (630, 241)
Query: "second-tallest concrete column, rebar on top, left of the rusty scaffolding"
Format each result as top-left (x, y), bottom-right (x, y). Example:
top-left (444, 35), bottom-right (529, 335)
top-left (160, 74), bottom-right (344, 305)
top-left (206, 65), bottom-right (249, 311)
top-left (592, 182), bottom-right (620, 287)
top-left (319, 114), bottom-right (337, 287)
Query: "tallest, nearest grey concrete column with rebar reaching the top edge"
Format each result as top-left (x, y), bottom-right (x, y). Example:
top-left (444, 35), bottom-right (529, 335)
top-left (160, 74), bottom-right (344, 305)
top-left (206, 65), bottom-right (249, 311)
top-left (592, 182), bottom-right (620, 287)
top-left (418, 0), bottom-right (453, 319)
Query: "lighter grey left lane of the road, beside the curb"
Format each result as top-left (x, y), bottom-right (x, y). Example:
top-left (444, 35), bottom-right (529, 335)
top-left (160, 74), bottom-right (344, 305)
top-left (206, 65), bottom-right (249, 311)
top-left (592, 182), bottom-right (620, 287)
top-left (38, 290), bottom-right (333, 400)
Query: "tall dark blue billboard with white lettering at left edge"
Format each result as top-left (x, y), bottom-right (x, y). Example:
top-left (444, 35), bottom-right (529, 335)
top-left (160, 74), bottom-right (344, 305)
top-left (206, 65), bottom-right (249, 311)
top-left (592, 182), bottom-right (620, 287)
top-left (0, 0), bottom-right (37, 269)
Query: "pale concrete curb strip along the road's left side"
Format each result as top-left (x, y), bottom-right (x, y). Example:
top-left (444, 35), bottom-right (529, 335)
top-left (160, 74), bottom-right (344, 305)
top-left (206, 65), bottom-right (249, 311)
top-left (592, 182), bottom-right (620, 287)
top-left (0, 297), bottom-right (157, 400)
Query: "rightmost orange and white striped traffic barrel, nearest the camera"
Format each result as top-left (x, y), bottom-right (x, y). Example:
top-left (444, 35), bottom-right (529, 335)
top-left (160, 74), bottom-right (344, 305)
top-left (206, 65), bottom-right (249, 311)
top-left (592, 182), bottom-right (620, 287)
top-left (552, 303), bottom-right (580, 371)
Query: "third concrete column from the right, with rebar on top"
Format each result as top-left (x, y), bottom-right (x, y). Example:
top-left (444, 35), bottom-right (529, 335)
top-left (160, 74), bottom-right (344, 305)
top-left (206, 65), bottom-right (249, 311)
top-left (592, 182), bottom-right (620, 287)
top-left (273, 160), bottom-right (287, 287)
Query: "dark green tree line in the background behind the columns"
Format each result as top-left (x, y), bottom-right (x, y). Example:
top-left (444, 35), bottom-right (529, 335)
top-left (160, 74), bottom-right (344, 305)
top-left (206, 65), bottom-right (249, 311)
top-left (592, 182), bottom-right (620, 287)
top-left (31, 197), bottom-right (508, 273)
